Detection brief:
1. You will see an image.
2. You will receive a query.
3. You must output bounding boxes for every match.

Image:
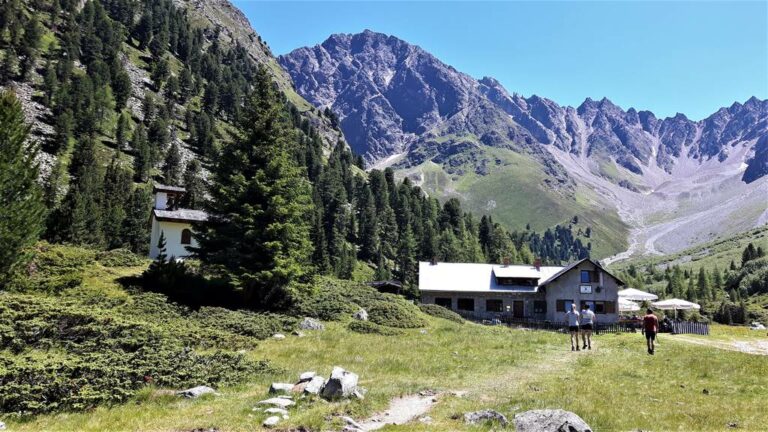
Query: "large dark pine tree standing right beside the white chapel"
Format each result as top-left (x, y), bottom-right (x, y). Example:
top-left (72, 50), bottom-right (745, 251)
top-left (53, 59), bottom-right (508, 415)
top-left (196, 67), bottom-right (313, 308)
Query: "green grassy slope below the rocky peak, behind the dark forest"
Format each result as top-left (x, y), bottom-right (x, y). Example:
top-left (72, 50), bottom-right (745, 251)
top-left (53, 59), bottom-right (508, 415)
top-left (401, 146), bottom-right (628, 258)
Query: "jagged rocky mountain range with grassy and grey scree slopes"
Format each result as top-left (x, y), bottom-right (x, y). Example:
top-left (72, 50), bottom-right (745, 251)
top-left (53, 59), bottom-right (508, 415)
top-left (278, 31), bottom-right (768, 262)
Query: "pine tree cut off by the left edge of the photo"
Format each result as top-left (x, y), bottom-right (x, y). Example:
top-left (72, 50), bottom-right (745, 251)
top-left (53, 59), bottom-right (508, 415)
top-left (0, 92), bottom-right (45, 288)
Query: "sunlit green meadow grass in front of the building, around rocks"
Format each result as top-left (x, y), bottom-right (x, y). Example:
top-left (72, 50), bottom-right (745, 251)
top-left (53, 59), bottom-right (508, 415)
top-left (9, 318), bottom-right (768, 431)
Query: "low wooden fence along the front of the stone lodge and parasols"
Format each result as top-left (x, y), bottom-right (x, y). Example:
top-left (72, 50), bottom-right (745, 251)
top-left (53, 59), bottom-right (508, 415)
top-left (456, 311), bottom-right (709, 335)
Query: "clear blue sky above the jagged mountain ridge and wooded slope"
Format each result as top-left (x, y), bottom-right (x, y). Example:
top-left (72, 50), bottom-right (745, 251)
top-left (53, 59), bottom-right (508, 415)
top-left (233, 0), bottom-right (768, 120)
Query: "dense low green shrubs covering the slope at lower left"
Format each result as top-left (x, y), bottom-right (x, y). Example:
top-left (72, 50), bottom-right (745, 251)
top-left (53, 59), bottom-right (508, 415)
top-left (0, 293), bottom-right (280, 416)
